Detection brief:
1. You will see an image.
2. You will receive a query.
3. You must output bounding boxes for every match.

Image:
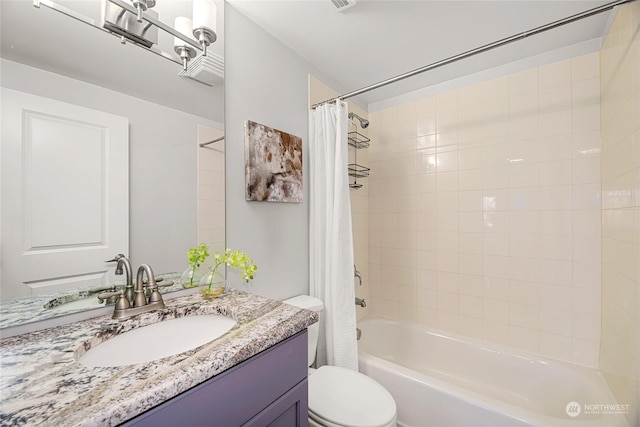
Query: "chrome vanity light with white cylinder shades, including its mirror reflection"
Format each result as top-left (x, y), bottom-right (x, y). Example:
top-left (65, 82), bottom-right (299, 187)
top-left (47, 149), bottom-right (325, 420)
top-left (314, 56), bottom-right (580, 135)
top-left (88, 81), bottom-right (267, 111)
top-left (33, 0), bottom-right (221, 75)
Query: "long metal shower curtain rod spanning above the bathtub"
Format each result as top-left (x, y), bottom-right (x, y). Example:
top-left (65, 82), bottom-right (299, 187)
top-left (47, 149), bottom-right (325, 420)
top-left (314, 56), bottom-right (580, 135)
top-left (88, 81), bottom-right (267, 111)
top-left (311, 0), bottom-right (635, 108)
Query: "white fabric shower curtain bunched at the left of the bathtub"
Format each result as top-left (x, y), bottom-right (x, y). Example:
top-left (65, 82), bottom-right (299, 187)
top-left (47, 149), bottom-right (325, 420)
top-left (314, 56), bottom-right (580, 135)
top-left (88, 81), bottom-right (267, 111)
top-left (309, 101), bottom-right (358, 370)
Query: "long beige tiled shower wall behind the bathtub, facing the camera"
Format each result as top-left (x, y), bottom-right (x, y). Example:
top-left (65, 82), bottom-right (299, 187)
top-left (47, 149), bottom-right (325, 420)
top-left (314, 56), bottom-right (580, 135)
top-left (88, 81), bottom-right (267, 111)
top-left (368, 53), bottom-right (601, 367)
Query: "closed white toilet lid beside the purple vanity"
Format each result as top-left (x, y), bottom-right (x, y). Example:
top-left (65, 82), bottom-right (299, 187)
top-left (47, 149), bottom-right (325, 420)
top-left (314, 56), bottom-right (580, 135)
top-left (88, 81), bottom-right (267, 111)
top-left (309, 366), bottom-right (396, 427)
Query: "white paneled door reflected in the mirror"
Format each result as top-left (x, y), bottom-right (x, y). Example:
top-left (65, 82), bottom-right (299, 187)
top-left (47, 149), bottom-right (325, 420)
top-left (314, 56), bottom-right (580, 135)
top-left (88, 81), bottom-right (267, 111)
top-left (0, 88), bottom-right (129, 299)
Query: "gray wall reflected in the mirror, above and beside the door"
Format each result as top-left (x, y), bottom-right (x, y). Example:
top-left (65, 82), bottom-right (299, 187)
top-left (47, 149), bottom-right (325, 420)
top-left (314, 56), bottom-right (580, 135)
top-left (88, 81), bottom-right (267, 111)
top-left (1, 59), bottom-right (223, 272)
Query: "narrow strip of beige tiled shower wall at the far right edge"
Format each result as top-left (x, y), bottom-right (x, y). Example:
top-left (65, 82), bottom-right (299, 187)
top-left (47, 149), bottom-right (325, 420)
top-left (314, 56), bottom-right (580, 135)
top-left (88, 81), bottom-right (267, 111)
top-left (600, 2), bottom-right (640, 426)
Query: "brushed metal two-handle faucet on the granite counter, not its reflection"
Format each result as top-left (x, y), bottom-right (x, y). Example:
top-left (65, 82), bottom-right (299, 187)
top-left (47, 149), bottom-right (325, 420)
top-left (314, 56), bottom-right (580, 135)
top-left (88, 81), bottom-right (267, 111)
top-left (98, 264), bottom-right (173, 320)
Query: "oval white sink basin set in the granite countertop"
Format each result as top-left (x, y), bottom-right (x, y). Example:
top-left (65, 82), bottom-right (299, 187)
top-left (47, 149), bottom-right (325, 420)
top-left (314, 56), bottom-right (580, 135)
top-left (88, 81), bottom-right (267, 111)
top-left (78, 314), bottom-right (236, 367)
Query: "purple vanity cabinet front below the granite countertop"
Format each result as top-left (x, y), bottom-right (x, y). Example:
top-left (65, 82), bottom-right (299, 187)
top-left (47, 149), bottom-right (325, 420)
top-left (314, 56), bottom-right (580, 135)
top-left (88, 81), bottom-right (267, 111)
top-left (123, 329), bottom-right (309, 427)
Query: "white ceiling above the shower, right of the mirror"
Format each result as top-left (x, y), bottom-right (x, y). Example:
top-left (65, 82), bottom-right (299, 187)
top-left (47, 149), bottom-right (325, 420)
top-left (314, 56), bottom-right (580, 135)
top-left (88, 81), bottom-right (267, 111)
top-left (228, 0), bottom-right (609, 105)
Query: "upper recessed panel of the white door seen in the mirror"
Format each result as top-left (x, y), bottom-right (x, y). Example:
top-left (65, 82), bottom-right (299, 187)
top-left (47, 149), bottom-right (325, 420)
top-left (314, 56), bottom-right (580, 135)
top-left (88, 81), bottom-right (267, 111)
top-left (22, 111), bottom-right (107, 249)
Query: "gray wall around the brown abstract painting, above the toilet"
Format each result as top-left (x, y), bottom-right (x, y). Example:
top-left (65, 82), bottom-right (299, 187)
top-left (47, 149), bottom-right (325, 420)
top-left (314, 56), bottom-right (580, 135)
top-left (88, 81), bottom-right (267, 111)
top-left (225, 4), bottom-right (342, 299)
